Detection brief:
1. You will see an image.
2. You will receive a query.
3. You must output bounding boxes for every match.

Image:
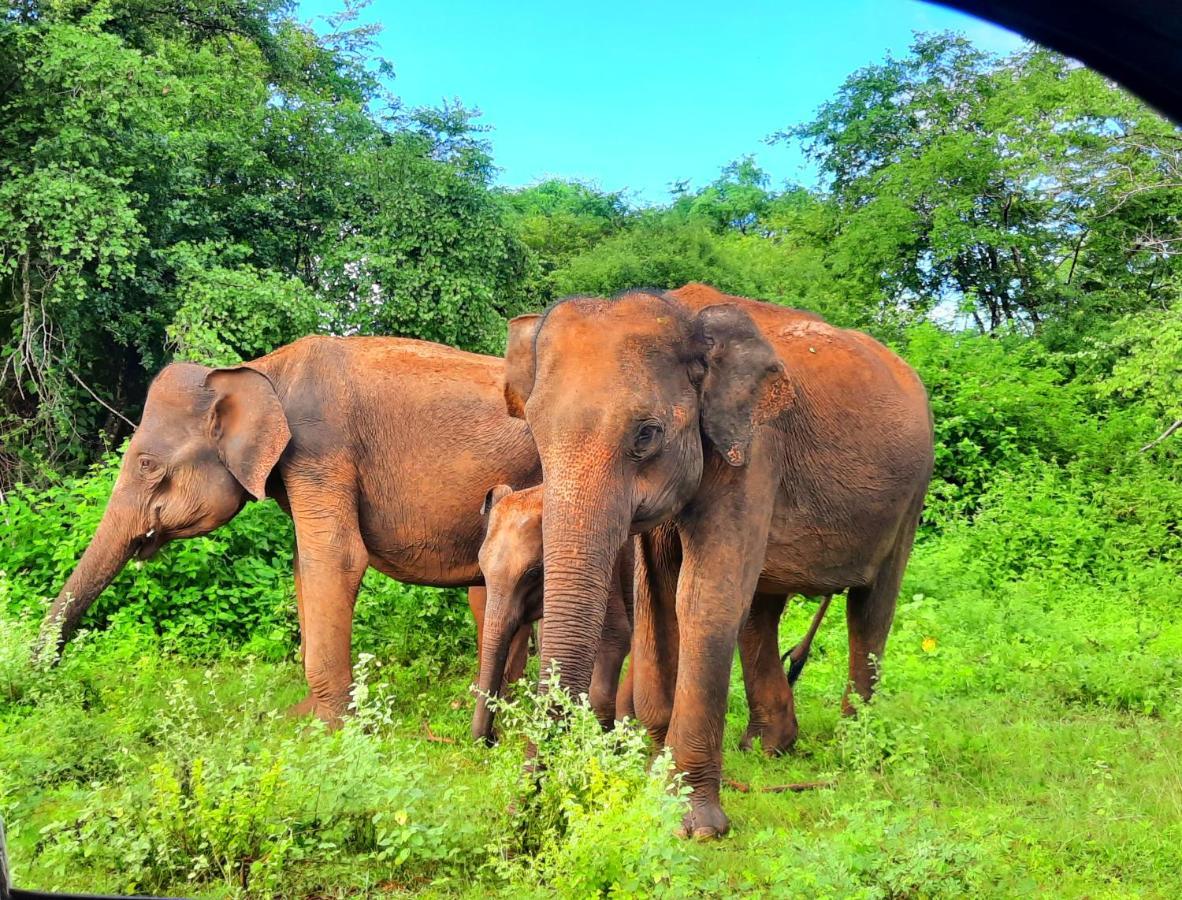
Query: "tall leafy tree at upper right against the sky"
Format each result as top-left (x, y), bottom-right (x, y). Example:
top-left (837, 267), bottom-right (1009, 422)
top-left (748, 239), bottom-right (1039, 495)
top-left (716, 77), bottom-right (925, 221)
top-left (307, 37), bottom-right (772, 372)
top-left (780, 34), bottom-right (1182, 331)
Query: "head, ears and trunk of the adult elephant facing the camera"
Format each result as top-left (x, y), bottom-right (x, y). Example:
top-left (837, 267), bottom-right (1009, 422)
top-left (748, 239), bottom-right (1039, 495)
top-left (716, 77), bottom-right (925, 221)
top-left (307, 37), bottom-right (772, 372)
top-left (505, 291), bottom-right (791, 692)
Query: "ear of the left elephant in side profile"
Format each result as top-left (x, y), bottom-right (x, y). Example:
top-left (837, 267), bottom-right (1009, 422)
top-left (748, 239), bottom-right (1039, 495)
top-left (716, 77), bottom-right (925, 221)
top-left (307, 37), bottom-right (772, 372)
top-left (206, 365), bottom-right (292, 500)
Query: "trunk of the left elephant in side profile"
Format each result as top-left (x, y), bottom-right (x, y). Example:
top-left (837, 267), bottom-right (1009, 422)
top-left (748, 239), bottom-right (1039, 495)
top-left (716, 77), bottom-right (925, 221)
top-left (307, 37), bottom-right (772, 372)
top-left (34, 503), bottom-right (139, 662)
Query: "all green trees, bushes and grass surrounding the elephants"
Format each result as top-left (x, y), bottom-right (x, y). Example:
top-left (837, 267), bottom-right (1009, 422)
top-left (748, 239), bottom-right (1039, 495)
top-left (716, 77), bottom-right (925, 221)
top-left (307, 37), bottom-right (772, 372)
top-left (0, 0), bottom-right (1182, 896)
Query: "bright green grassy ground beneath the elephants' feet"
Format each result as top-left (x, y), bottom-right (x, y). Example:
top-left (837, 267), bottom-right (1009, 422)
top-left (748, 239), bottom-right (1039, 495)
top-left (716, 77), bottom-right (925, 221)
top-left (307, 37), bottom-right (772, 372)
top-left (0, 529), bottom-right (1182, 898)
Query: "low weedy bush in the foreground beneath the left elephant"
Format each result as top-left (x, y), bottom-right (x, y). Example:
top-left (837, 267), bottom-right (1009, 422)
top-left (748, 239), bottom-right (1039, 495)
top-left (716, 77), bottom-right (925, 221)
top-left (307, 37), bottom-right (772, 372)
top-left (31, 665), bottom-right (484, 896)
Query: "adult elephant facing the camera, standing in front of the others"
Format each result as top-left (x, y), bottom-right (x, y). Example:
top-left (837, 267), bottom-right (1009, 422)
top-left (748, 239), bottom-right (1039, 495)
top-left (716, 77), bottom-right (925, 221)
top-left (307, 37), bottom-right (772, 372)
top-left (506, 285), bottom-right (933, 837)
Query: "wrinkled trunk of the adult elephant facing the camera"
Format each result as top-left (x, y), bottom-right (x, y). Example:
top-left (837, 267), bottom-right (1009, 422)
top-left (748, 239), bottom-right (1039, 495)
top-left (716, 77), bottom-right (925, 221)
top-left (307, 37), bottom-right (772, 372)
top-left (541, 473), bottom-right (631, 697)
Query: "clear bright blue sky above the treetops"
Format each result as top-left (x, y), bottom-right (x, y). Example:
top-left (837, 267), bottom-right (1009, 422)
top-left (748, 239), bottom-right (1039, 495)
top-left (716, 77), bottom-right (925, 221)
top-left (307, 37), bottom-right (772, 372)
top-left (290, 0), bottom-right (1020, 202)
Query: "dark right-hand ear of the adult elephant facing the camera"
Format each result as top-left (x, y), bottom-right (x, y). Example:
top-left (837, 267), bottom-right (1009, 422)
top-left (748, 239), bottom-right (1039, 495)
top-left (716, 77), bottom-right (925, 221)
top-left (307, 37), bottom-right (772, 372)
top-left (694, 303), bottom-right (785, 466)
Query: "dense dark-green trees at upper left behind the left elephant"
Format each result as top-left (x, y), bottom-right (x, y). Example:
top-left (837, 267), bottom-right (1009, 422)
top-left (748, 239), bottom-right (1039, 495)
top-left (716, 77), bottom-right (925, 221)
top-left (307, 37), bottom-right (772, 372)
top-left (0, 0), bottom-right (528, 487)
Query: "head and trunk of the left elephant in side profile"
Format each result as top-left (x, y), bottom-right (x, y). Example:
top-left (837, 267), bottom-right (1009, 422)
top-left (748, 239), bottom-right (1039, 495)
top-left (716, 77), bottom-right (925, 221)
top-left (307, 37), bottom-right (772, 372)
top-left (38, 363), bottom-right (291, 659)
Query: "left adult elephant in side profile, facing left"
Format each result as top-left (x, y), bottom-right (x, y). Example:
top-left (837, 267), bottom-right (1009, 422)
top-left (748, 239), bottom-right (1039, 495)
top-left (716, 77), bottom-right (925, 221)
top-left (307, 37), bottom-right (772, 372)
top-left (32, 337), bottom-right (540, 721)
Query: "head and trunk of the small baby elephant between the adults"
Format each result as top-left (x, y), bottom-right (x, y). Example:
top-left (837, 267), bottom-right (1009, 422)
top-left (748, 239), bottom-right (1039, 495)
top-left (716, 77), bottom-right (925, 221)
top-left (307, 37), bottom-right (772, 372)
top-left (472, 485), bottom-right (543, 743)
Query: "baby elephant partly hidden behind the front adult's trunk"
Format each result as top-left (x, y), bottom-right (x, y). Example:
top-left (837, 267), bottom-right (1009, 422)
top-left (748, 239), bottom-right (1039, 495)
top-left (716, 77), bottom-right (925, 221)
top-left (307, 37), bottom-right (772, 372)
top-left (472, 485), bottom-right (634, 743)
